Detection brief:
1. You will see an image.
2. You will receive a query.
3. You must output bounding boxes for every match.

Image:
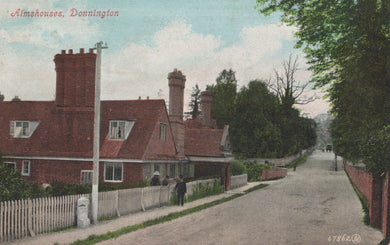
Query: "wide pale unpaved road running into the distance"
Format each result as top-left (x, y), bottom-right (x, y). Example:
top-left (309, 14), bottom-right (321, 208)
top-left (101, 152), bottom-right (383, 245)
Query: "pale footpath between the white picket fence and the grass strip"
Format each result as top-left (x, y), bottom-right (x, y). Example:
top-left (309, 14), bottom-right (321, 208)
top-left (8, 182), bottom-right (261, 245)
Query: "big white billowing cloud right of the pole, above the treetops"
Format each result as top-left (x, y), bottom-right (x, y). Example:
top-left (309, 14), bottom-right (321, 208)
top-left (103, 21), bottom-right (294, 98)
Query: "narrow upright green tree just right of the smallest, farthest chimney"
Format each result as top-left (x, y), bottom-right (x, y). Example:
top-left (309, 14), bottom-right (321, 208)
top-left (206, 69), bottom-right (237, 128)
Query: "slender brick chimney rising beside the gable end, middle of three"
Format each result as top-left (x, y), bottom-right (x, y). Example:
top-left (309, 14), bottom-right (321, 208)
top-left (168, 69), bottom-right (186, 157)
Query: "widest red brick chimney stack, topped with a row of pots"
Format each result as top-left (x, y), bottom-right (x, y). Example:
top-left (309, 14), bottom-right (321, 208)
top-left (54, 49), bottom-right (96, 111)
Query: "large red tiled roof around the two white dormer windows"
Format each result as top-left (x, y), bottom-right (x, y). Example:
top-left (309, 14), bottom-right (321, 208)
top-left (0, 100), bottom-right (174, 159)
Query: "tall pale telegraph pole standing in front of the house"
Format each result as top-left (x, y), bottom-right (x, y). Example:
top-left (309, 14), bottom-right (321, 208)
top-left (92, 42), bottom-right (108, 225)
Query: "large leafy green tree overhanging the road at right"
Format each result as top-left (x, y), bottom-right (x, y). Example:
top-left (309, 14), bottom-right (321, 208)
top-left (257, 0), bottom-right (390, 172)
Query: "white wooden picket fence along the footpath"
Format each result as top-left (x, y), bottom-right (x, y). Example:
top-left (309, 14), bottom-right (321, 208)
top-left (0, 179), bottom-right (232, 242)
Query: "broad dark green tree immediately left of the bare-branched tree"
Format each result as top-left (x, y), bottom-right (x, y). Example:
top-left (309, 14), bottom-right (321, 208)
top-left (230, 80), bottom-right (281, 157)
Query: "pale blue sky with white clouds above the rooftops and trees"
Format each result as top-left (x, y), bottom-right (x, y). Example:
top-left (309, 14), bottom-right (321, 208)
top-left (0, 0), bottom-right (329, 117)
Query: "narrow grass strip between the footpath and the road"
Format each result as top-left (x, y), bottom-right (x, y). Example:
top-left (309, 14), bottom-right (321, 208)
top-left (71, 184), bottom-right (268, 245)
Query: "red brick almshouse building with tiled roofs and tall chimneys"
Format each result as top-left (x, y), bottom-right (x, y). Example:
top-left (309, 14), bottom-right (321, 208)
top-left (0, 49), bottom-right (232, 188)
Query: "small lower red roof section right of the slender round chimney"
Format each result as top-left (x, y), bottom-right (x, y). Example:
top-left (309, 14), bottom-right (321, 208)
top-left (184, 128), bottom-right (223, 157)
